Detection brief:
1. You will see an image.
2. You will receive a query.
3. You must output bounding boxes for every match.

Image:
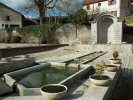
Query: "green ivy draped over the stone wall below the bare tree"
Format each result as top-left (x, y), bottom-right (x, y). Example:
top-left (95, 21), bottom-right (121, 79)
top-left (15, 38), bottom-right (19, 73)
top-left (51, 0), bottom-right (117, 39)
top-left (17, 24), bottom-right (61, 42)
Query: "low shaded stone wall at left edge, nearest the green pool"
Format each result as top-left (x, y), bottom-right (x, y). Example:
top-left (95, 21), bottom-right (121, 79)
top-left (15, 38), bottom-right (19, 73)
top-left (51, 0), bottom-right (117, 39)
top-left (0, 58), bottom-right (35, 74)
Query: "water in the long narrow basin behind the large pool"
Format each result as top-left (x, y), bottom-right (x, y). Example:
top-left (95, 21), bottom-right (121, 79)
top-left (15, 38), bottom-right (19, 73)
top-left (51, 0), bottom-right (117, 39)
top-left (69, 52), bottom-right (102, 64)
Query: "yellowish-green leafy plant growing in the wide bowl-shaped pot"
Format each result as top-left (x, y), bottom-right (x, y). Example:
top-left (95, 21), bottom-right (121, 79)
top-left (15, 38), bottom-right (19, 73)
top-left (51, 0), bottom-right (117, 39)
top-left (96, 60), bottom-right (106, 76)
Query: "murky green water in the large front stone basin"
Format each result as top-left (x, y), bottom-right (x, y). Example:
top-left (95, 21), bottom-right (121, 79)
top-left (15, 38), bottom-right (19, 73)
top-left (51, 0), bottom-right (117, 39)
top-left (18, 67), bottom-right (79, 88)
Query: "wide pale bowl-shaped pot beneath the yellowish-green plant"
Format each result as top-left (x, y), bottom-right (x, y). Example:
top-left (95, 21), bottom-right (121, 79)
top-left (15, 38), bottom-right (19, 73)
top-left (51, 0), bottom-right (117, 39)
top-left (89, 75), bottom-right (111, 86)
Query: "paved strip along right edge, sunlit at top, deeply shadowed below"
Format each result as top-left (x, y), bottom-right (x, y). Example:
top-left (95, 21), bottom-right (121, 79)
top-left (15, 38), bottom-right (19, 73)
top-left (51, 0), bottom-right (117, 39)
top-left (112, 54), bottom-right (133, 100)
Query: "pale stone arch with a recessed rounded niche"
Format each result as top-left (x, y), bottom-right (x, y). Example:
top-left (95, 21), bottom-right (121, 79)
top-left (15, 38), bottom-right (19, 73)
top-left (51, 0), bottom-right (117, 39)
top-left (91, 13), bottom-right (122, 44)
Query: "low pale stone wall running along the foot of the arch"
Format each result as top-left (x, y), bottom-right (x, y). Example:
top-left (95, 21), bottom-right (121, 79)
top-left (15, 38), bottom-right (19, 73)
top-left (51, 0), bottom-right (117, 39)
top-left (75, 44), bottom-right (132, 53)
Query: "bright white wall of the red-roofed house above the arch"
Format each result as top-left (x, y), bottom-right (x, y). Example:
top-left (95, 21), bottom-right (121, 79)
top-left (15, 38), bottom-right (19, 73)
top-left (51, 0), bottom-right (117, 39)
top-left (83, 0), bottom-right (130, 17)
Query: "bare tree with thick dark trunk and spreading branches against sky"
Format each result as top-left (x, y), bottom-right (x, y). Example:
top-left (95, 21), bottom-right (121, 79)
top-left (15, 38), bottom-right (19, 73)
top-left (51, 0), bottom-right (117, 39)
top-left (23, 0), bottom-right (58, 24)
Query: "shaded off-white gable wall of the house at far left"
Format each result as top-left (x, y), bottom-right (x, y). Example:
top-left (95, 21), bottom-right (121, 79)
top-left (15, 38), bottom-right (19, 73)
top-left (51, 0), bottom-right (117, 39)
top-left (0, 6), bottom-right (22, 29)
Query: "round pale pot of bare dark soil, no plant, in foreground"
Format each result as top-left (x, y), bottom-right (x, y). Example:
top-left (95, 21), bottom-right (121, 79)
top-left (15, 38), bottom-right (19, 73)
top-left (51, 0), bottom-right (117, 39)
top-left (40, 84), bottom-right (67, 100)
